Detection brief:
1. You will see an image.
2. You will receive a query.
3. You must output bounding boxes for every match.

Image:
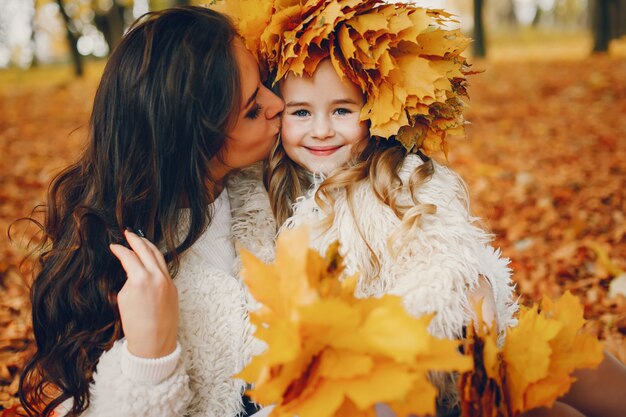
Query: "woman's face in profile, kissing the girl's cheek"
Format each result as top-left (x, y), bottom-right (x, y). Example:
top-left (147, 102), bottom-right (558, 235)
top-left (211, 39), bottom-right (284, 180)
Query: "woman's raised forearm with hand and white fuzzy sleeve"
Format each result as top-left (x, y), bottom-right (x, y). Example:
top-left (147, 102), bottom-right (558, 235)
top-left (70, 232), bottom-right (191, 417)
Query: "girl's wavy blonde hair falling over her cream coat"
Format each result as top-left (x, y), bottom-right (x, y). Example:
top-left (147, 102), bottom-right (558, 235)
top-left (263, 138), bottom-right (436, 269)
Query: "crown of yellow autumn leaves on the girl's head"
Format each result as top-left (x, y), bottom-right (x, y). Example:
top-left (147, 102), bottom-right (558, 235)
top-left (213, 0), bottom-right (470, 153)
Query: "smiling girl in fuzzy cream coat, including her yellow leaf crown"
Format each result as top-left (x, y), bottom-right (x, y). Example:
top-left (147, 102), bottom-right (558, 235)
top-left (222, 0), bottom-right (619, 416)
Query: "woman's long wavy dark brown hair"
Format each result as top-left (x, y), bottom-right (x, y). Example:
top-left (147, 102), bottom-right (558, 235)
top-left (20, 7), bottom-right (241, 417)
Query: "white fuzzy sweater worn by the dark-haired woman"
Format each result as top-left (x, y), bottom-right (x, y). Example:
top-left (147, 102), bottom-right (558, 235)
top-left (75, 189), bottom-right (263, 417)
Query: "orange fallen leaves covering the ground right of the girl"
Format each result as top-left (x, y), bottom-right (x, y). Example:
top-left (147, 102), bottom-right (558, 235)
top-left (449, 55), bottom-right (626, 363)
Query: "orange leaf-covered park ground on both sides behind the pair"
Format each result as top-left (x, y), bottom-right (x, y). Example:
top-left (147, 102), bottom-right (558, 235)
top-left (0, 30), bottom-right (626, 411)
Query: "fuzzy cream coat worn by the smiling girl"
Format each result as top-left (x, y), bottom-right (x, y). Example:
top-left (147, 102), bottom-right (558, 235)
top-left (233, 155), bottom-right (518, 337)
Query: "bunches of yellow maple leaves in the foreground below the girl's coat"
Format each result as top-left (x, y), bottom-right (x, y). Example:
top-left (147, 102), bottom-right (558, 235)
top-left (243, 229), bottom-right (604, 417)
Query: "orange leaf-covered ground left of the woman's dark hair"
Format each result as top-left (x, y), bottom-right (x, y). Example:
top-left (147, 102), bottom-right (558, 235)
top-left (0, 63), bottom-right (100, 408)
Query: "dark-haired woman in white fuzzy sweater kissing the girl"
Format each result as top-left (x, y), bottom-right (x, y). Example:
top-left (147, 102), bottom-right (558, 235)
top-left (20, 7), bottom-right (283, 416)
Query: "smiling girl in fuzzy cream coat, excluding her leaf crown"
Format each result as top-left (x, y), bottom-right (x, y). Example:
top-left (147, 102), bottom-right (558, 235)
top-left (268, 56), bottom-right (516, 337)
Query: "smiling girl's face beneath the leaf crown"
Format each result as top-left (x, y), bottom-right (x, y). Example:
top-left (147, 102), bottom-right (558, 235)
top-left (280, 60), bottom-right (369, 175)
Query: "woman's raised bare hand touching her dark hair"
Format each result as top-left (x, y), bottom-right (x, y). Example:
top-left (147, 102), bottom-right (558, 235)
top-left (110, 231), bottom-right (178, 358)
